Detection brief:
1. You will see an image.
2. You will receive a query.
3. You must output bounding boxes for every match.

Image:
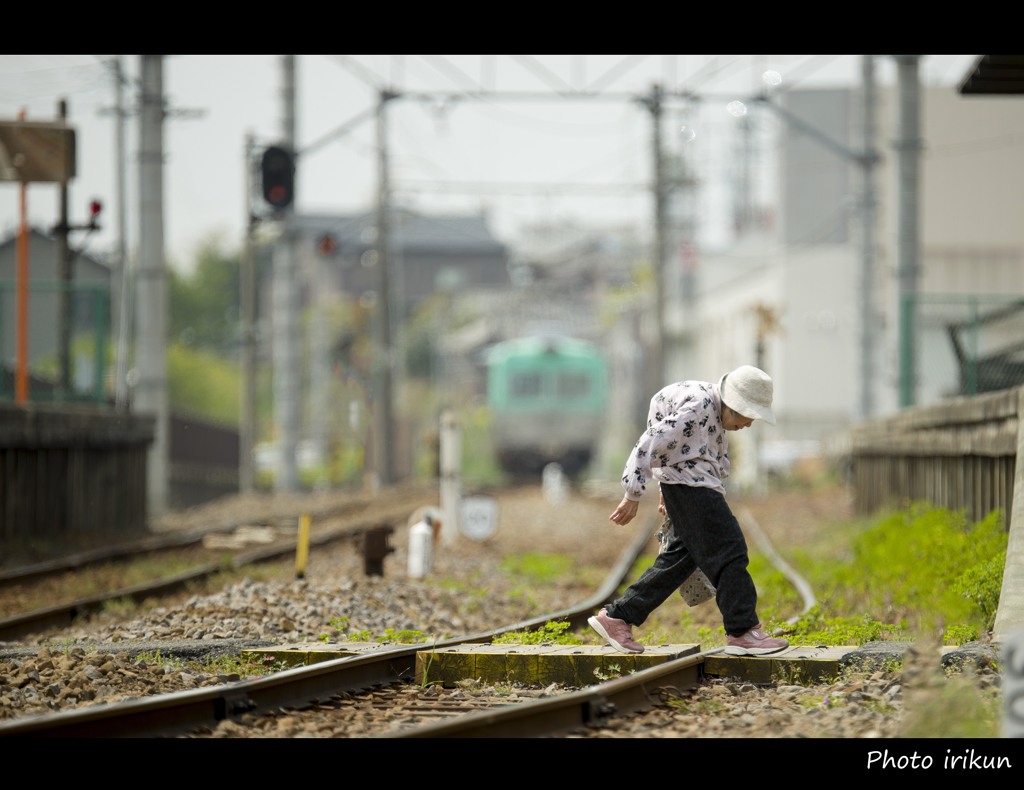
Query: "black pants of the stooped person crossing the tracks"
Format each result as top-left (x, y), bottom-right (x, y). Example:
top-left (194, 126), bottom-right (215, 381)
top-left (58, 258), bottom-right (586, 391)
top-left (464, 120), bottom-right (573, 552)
top-left (606, 485), bottom-right (760, 636)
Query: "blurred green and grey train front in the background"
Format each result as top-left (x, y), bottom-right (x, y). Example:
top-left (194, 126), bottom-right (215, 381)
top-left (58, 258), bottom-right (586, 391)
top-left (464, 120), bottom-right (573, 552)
top-left (486, 336), bottom-right (608, 477)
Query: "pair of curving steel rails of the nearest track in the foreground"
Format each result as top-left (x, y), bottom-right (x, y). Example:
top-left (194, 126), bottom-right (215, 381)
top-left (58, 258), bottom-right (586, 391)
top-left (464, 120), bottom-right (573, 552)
top-left (0, 510), bottom-right (659, 738)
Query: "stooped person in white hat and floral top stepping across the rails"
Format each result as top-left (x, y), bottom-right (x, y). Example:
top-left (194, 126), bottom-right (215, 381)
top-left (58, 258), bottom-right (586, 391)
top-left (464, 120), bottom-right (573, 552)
top-left (588, 365), bottom-right (790, 656)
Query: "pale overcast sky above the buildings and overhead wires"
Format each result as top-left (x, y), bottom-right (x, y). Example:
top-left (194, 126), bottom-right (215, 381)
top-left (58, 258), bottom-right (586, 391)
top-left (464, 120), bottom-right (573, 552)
top-left (0, 54), bottom-right (977, 271)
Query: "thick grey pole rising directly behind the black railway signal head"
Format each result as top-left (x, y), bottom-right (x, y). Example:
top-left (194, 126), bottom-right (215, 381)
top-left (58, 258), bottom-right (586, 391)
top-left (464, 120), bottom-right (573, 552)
top-left (273, 55), bottom-right (299, 492)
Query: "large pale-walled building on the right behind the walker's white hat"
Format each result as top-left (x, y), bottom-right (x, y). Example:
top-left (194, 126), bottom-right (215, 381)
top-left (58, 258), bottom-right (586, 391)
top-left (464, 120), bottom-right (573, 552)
top-left (666, 71), bottom-right (1024, 475)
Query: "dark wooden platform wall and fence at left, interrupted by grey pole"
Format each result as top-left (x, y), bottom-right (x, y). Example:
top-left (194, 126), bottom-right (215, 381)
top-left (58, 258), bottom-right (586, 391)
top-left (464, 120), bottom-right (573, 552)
top-left (0, 402), bottom-right (245, 545)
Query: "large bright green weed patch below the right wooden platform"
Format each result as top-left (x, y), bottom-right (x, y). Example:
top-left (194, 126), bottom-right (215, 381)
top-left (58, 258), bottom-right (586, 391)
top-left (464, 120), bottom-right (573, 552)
top-left (751, 502), bottom-right (1007, 645)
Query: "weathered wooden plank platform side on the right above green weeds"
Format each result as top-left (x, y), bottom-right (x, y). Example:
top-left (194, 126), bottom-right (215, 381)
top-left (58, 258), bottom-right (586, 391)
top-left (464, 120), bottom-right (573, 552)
top-left (851, 387), bottom-right (1022, 529)
